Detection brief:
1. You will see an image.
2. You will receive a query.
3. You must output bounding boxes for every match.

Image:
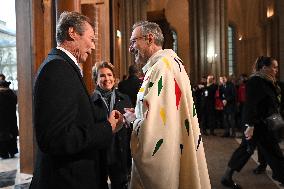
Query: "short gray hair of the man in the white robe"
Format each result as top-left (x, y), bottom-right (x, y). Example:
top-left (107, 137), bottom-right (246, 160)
top-left (132, 21), bottom-right (164, 46)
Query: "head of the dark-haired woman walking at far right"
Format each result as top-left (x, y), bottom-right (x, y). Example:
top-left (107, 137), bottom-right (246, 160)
top-left (254, 56), bottom-right (278, 79)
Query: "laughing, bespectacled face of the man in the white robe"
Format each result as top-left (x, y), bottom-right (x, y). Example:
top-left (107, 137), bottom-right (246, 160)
top-left (129, 26), bottom-right (150, 64)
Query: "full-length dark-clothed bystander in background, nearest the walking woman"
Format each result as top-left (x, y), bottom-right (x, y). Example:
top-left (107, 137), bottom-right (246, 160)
top-left (222, 76), bottom-right (237, 137)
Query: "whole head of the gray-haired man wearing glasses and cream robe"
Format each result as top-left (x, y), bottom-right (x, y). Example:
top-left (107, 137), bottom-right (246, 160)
top-left (129, 21), bottom-right (164, 65)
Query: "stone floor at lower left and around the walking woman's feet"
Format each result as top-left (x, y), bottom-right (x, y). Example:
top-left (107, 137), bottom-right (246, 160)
top-left (0, 130), bottom-right (284, 189)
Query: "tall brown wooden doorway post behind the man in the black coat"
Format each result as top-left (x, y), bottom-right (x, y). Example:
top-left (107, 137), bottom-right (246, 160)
top-left (15, 0), bottom-right (54, 173)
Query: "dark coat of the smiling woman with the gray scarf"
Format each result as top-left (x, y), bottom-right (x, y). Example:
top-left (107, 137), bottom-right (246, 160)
top-left (92, 90), bottom-right (132, 185)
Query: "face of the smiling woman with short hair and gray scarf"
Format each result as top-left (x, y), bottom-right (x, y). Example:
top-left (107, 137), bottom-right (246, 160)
top-left (97, 68), bottom-right (115, 91)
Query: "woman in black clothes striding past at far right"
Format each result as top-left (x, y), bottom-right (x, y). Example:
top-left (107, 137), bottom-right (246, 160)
top-left (221, 56), bottom-right (284, 189)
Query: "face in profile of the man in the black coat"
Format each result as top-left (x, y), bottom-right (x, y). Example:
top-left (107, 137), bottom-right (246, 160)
top-left (74, 22), bottom-right (95, 63)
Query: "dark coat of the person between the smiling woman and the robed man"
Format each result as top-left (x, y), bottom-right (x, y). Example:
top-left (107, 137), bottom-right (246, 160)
top-left (118, 75), bottom-right (142, 107)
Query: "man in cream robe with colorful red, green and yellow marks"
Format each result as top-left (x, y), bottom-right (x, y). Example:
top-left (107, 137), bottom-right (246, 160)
top-left (125, 21), bottom-right (211, 189)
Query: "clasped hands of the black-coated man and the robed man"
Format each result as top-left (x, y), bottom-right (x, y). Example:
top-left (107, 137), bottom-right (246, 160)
top-left (108, 108), bottom-right (136, 133)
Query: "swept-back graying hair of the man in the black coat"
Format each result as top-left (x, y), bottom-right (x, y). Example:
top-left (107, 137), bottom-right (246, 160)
top-left (56, 11), bottom-right (92, 44)
